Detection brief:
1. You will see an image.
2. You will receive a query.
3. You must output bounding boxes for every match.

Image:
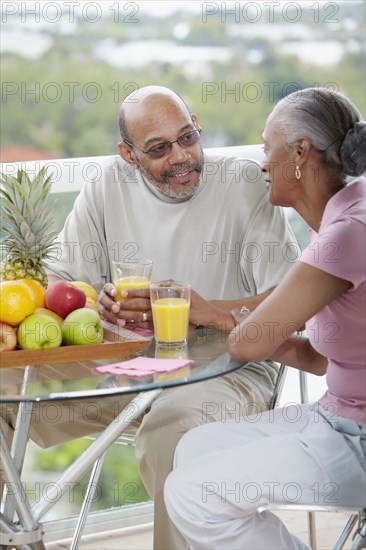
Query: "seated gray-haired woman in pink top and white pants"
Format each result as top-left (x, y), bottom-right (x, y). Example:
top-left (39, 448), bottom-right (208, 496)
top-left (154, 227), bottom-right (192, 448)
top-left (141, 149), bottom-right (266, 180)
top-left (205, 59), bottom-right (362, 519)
top-left (165, 88), bottom-right (366, 550)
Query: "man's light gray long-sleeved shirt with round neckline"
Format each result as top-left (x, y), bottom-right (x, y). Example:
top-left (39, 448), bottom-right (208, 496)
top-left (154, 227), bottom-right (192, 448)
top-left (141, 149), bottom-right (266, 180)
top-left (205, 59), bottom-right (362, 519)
top-left (48, 154), bottom-right (297, 299)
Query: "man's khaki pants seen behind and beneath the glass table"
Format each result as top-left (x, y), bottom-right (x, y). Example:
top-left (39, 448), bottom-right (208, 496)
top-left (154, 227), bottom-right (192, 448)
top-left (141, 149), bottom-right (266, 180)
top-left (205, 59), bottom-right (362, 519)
top-left (0, 364), bottom-right (277, 550)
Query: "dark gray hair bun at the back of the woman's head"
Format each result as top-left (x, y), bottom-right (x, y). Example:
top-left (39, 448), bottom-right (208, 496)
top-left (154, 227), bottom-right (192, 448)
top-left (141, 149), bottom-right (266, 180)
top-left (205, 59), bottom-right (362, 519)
top-left (340, 120), bottom-right (366, 176)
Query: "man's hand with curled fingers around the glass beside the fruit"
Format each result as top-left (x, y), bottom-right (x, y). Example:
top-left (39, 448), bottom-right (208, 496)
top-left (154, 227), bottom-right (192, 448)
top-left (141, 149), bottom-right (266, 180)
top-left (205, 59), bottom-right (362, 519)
top-left (98, 283), bottom-right (152, 328)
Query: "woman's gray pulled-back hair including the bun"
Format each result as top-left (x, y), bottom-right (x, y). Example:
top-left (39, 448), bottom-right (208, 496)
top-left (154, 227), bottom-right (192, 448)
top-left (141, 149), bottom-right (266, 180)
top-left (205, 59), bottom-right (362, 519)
top-left (273, 88), bottom-right (366, 177)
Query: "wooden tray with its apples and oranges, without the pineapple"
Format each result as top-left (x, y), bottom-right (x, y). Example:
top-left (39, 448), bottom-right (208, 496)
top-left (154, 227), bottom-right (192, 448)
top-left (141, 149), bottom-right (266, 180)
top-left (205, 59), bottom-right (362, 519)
top-left (0, 279), bottom-right (150, 367)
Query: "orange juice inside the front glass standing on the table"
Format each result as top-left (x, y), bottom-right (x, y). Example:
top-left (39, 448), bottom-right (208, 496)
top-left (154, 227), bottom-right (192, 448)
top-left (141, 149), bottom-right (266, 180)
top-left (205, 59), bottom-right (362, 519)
top-left (152, 298), bottom-right (189, 343)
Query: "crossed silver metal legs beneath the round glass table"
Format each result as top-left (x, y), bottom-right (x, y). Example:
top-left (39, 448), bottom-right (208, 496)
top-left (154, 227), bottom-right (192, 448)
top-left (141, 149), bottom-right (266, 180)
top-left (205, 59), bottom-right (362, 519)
top-left (0, 390), bottom-right (163, 550)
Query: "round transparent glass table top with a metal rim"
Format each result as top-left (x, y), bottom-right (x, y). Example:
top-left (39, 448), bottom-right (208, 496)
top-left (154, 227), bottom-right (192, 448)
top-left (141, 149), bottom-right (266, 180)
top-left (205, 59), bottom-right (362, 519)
top-left (0, 328), bottom-right (243, 403)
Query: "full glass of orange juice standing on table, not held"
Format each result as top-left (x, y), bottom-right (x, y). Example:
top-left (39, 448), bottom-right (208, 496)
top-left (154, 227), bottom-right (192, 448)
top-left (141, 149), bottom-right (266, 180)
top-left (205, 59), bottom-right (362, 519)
top-left (150, 281), bottom-right (191, 346)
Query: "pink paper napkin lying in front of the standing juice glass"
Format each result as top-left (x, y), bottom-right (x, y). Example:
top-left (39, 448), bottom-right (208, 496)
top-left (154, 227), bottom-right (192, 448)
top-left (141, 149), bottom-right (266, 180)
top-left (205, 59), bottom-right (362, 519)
top-left (93, 357), bottom-right (193, 377)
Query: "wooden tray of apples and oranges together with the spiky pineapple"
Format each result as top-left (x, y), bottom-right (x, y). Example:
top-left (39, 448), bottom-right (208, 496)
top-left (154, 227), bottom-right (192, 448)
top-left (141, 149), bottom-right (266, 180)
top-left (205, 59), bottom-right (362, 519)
top-left (0, 169), bottom-right (150, 367)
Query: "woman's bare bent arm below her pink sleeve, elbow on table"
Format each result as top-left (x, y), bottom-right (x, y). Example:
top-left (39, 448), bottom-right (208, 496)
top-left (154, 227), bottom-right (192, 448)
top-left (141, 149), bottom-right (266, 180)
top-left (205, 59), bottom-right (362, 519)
top-left (229, 261), bottom-right (352, 374)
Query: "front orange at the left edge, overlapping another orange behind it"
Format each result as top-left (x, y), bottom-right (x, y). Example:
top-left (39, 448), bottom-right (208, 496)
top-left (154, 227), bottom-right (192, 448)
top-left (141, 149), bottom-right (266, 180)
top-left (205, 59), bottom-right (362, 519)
top-left (0, 280), bottom-right (36, 326)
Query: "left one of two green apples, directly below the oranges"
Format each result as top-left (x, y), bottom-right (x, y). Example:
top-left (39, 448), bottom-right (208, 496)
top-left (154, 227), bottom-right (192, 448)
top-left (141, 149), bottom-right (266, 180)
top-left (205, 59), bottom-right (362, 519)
top-left (18, 313), bottom-right (62, 350)
